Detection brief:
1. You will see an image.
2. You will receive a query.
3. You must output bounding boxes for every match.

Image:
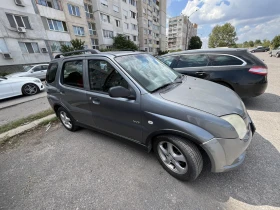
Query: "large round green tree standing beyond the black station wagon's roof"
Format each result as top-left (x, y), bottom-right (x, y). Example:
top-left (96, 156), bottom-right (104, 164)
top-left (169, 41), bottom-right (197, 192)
top-left (208, 23), bottom-right (238, 48)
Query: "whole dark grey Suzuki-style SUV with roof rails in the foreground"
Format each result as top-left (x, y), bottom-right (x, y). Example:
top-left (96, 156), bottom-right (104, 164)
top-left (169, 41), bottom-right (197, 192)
top-left (46, 50), bottom-right (255, 181)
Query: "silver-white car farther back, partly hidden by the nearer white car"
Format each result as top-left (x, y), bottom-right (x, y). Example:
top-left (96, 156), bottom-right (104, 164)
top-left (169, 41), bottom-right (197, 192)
top-left (6, 63), bottom-right (49, 80)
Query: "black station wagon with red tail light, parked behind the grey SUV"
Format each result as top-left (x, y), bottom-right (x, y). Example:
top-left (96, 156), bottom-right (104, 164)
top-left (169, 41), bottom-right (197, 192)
top-left (158, 49), bottom-right (268, 98)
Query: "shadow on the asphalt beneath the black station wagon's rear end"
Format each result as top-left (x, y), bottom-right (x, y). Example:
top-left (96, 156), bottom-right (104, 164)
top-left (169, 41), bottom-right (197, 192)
top-left (243, 93), bottom-right (280, 112)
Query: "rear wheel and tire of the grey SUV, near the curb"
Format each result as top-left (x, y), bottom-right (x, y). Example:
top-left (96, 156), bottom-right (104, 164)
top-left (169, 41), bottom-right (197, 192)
top-left (57, 107), bottom-right (79, 132)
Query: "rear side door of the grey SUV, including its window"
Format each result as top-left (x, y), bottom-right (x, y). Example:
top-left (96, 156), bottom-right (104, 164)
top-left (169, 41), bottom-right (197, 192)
top-left (59, 58), bottom-right (92, 125)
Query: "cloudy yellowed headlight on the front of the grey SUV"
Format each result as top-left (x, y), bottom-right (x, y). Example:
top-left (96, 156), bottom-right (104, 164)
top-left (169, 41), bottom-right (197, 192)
top-left (221, 114), bottom-right (247, 139)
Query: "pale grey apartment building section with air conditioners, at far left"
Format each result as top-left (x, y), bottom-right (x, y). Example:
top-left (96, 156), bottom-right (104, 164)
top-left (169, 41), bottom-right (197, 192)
top-left (0, 0), bottom-right (50, 72)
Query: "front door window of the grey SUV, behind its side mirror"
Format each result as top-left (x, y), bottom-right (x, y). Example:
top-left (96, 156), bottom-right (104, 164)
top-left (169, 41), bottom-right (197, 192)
top-left (88, 60), bottom-right (128, 92)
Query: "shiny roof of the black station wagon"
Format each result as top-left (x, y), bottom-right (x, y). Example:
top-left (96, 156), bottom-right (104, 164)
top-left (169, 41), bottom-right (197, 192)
top-left (159, 48), bottom-right (248, 57)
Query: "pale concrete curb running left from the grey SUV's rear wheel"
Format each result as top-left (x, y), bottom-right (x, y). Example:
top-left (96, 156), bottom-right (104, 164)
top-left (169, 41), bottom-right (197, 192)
top-left (0, 114), bottom-right (56, 143)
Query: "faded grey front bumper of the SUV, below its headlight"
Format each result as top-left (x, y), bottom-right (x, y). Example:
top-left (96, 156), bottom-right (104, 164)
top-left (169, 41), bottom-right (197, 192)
top-left (201, 122), bottom-right (256, 173)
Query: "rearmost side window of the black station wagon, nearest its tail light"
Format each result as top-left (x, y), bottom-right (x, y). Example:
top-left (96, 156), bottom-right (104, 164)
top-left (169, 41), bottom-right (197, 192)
top-left (209, 55), bottom-right (243, 66)
